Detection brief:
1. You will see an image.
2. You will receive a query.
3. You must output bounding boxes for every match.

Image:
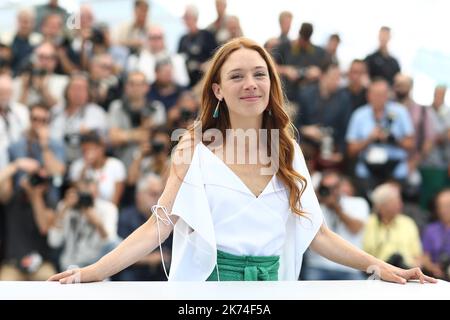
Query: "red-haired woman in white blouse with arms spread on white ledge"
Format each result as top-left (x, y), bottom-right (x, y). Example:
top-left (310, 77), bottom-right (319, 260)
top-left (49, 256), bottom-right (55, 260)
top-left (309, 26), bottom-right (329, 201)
top-left (50, 38), bottom-right (435, 283)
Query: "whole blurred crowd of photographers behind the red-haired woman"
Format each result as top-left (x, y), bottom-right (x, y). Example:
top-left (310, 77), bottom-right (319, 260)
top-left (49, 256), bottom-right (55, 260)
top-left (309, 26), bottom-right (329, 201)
top-left (0, 0), bottom-right (450, 280)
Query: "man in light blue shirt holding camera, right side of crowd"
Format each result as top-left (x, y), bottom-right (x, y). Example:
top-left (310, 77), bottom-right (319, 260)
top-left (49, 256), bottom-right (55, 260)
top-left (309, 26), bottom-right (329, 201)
top-left (346, 80), bottom-right (414, 196)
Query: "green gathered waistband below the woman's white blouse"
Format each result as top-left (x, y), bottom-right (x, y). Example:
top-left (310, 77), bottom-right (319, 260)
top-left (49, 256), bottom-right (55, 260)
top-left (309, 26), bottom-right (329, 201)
top-left (207, 250), bottom-right (280, 281)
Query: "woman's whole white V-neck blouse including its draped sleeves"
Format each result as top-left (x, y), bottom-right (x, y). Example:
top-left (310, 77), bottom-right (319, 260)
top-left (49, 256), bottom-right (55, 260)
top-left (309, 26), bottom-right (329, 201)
top-left (162, 142), bottom-right (323, 281)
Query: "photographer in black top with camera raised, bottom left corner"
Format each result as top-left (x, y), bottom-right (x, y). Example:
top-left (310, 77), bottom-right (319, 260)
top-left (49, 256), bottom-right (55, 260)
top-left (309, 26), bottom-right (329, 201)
top-left (0, 168), bottom-right (55, 281)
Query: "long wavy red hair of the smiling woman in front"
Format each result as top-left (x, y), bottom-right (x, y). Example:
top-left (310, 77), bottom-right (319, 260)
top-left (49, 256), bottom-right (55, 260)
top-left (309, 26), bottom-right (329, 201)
top-left (185, 37), bottom-right (307, 216)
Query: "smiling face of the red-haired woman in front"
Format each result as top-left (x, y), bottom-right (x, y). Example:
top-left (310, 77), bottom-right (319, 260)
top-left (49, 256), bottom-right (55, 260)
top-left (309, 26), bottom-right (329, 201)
top-left (213, 48), bottom-right (270, 117)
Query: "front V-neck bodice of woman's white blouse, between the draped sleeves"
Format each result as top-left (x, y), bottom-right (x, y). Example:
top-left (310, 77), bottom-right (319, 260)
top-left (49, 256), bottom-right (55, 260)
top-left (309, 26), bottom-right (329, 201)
top-left (199, 144), bottom-right (289, 256)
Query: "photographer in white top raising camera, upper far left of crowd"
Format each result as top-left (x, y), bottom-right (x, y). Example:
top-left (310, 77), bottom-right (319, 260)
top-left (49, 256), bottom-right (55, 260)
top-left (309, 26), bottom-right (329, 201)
top-left (13, 41), bottom-right (68, 107)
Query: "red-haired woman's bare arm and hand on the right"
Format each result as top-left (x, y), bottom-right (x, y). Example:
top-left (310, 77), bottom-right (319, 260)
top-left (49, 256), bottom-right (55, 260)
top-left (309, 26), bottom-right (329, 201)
top-left (311, 225), bottom-right (436, 284)
